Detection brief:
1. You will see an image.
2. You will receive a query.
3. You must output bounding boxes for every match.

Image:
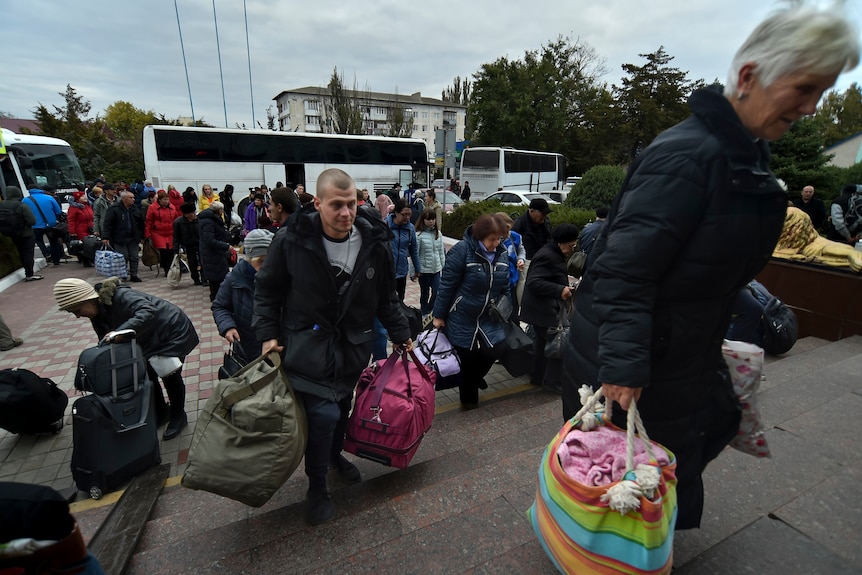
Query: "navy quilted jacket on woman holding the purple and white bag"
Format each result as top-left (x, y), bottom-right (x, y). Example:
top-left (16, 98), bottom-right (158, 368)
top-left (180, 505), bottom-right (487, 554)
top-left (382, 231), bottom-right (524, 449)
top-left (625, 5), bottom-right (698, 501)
top-left (434, 230), bottom-right (511, 349)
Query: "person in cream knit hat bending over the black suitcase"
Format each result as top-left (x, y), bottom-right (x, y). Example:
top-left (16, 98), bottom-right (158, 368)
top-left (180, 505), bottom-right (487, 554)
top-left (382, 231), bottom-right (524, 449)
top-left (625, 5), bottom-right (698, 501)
top-left (54, 278), bottom-right (200, 439)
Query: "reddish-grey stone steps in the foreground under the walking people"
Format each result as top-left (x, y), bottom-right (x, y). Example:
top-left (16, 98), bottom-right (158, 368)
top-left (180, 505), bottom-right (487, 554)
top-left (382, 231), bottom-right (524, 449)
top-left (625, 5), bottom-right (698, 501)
top-left (72, 337), bottom-right (862, 575)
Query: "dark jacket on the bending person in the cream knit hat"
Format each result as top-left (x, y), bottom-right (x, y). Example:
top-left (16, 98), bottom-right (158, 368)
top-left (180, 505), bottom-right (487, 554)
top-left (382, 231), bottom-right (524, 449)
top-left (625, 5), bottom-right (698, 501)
top-left (91, 279), bottom-right (200, 358)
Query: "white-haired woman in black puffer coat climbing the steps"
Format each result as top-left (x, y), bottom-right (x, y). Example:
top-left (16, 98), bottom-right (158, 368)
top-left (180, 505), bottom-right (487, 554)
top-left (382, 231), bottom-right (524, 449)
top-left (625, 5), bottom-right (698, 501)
top-left (563, 3), bottom-right (859, 529)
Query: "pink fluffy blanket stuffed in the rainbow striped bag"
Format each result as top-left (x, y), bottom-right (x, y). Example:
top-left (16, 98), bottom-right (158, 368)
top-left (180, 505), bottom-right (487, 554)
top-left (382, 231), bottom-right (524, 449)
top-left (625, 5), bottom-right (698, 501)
top-left (557, 426), bottom-right (670, 487)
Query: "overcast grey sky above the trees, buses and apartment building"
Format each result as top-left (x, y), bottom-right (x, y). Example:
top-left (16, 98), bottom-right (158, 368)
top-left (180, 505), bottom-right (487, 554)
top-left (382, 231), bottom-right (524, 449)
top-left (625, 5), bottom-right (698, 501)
top-left (0, 0), bottom-right (862, 127)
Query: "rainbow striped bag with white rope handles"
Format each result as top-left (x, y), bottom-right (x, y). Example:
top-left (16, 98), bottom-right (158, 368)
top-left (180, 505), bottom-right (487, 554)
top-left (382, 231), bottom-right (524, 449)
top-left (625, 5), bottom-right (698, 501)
top-left (527, 386), bottom-right (677, 575)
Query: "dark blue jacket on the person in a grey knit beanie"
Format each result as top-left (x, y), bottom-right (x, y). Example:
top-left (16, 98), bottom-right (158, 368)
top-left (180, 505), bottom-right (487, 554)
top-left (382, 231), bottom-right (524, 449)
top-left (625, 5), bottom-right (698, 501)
top-left (211, 260), bottom-right (260, 363)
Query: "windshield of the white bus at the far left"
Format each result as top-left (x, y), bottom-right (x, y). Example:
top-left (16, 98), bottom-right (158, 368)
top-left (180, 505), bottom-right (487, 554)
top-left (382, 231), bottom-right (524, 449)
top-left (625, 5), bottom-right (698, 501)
top-left (7, 143), bottom-right (84, 190)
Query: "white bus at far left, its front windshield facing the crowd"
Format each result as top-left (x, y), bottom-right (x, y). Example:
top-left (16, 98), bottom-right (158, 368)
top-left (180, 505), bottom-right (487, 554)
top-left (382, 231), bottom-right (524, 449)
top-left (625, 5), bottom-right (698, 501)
top-left (0, 128), bottom-right (84, 202)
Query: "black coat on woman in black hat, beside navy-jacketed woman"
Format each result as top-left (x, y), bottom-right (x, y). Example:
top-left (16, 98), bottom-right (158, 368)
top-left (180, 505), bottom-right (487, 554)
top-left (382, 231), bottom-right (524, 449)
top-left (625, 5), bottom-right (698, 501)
top-left (521, 242), bottom-right (569, 328)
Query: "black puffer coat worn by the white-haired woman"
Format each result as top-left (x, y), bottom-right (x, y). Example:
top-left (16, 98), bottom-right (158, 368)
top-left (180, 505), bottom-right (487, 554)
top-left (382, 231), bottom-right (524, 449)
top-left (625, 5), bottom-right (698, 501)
top-left (564, 85), bottom-right (787, 416)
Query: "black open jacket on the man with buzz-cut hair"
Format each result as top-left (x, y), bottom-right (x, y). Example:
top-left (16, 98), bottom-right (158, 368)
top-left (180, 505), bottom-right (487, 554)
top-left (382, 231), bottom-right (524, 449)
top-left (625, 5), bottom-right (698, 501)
top-left (253, 210), bottom-right (410, 401)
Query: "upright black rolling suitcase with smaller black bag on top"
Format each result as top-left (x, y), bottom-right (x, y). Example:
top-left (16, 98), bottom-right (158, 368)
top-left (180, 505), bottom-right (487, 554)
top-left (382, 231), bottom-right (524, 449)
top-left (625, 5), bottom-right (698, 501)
top-left (72, 332), bottom-right (161, 499)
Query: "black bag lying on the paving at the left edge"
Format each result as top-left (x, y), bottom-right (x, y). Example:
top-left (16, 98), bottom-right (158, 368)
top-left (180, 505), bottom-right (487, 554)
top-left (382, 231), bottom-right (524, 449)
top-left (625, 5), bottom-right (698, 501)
top-left (0, 369), bottom-right (69, 434)
